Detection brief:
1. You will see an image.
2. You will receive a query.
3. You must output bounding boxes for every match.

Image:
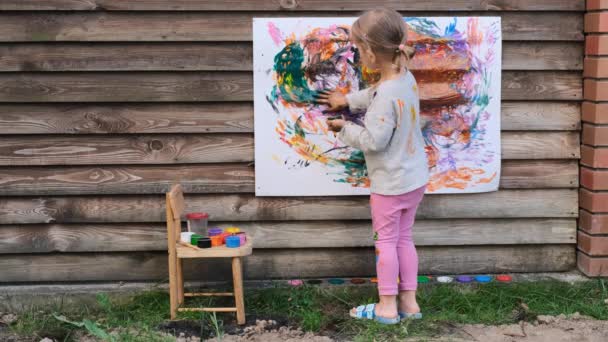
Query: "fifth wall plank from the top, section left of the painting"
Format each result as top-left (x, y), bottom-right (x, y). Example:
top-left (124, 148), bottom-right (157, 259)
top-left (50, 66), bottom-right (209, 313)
top-left (0, 102), bottom-right (254, 134)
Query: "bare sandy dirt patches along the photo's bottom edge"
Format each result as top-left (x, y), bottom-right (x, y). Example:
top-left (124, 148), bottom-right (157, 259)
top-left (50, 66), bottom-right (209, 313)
top-left (0, 314), bottom-right (608, 342)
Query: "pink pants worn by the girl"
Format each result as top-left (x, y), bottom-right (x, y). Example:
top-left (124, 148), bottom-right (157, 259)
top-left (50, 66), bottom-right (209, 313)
top-left (370, 186), bottom-right (426, 296)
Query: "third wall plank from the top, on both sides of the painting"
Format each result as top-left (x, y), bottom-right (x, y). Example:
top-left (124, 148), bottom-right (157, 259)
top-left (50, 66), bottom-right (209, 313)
top-left (0, 41), bottom-right (583, 71)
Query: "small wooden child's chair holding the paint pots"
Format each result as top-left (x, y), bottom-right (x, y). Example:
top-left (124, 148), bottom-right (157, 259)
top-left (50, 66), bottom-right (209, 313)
top-left (167, 185), bottom-right (252, 324)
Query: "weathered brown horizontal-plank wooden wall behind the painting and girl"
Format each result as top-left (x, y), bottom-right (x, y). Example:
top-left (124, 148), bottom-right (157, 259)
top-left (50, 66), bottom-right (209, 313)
top-left (0, 0), bottom-right (584, 282)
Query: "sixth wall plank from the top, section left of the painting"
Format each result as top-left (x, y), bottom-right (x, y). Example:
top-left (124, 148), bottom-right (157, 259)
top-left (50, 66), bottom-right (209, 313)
top-left (0, 134), bottom-right (253, 165)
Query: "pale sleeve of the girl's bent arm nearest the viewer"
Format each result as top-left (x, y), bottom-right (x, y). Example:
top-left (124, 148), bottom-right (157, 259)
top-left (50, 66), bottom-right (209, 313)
top-left (338, 99), bottom-right (397, 153)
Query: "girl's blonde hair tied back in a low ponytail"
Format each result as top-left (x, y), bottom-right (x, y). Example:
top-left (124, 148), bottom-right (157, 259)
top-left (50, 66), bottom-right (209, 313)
top-left (351, 8), bottom-right (415, 71)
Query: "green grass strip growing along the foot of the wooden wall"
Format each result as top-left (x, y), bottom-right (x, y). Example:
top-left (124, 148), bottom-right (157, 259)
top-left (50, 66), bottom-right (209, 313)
top-left (11, 280), bottom-right (608, 342)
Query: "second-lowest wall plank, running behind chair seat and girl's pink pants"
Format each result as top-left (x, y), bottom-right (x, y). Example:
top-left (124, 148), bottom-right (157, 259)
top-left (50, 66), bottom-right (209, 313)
top-left (0, 219), bottom-right (576, 254)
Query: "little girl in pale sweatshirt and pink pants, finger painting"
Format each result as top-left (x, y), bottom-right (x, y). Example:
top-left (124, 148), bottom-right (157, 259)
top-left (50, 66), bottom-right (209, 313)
top-left (318, 9), bottom-right (429, 324)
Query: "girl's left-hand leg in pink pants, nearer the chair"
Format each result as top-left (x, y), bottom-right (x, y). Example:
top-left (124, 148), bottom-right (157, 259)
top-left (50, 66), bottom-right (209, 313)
top-left (370, 194), bottom-right (401, 317)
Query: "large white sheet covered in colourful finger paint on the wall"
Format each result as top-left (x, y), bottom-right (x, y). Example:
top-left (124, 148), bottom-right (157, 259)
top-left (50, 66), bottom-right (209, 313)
top-left (253, 17), bottom-right (501, 196)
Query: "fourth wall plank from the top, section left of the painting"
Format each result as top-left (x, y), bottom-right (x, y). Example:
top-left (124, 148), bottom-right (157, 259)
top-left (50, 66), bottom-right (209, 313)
top-left (0, 72), bottom-right (253, 102)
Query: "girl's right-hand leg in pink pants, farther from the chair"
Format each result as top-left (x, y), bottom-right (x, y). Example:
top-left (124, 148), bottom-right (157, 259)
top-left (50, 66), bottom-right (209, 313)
top-left (397, 187), bottom-right (425, 313)
